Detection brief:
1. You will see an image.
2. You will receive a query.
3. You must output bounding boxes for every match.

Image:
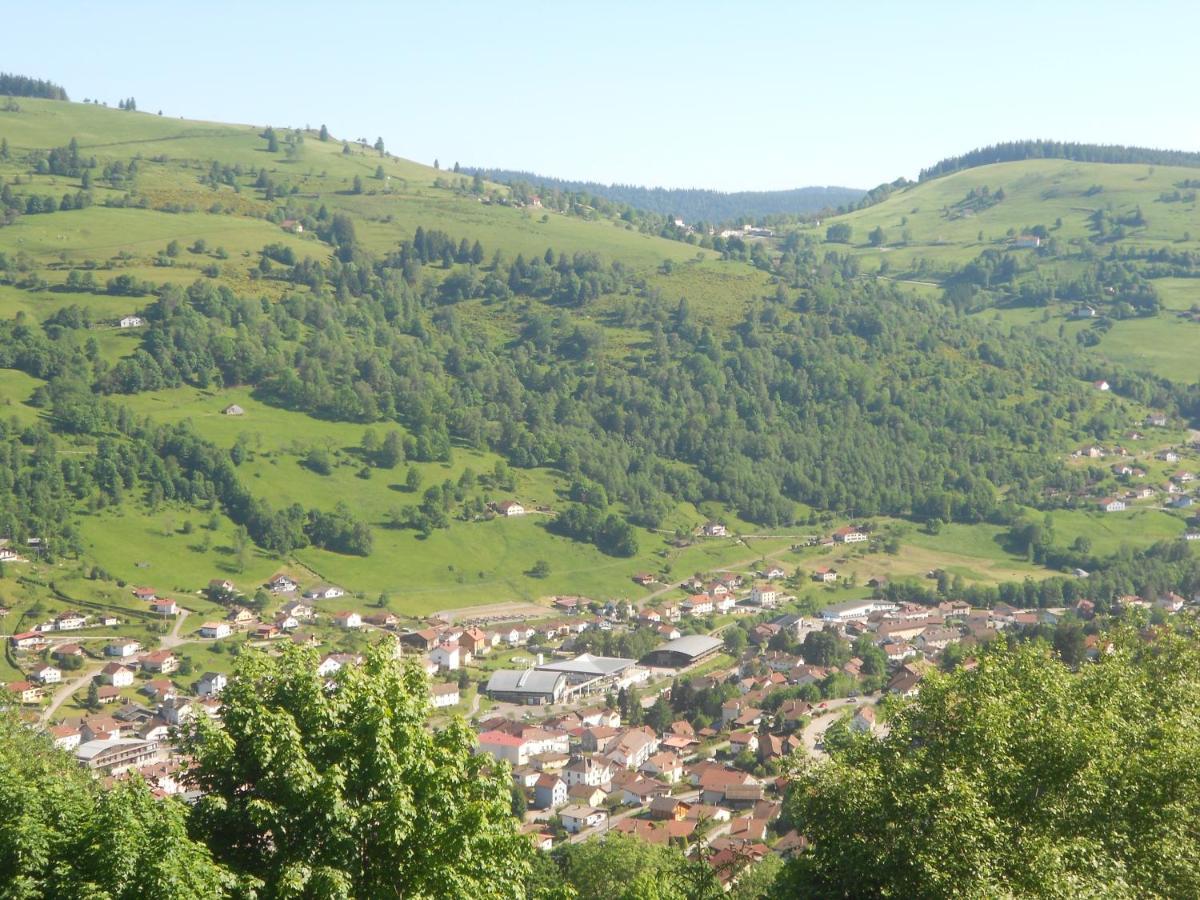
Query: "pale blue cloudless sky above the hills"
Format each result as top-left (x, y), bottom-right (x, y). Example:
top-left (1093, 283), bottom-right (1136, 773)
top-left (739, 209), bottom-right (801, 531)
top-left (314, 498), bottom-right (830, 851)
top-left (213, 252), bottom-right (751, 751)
top-left (0, 0), bottom-right (1200, 190)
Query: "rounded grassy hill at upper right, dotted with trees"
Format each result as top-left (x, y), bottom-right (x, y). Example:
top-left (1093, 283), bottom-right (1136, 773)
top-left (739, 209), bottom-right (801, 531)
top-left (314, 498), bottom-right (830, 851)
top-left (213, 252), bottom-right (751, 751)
top-left (802, 160), bottom-right (1200, 383)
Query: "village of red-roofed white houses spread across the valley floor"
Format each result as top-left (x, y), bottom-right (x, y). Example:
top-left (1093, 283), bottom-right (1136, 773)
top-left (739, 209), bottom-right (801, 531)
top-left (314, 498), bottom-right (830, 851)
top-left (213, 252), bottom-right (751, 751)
top-left (5, 502), bottom-right (1195, 878)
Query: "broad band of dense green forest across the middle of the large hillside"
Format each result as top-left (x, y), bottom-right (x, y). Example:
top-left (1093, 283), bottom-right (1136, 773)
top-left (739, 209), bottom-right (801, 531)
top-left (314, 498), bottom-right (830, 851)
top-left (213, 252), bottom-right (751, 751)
top-left (0, 208), bottom-right (1190, 556)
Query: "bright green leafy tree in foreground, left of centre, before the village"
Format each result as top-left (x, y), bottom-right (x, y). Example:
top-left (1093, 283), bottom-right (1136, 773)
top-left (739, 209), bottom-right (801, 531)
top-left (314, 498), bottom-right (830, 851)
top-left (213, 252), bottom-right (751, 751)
top-left (184, 647), bottom-right (532, 899)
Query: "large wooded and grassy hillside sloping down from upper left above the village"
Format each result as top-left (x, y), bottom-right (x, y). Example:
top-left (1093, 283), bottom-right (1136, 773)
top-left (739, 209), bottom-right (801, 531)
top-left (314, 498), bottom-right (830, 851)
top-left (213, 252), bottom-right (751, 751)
top-left (0, 101), bottom-right (1194, 607)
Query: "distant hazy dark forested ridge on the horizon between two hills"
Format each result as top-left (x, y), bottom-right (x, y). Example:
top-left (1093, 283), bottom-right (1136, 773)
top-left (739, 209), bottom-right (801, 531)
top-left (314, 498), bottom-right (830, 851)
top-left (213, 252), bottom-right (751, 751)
top-left (463, 168), bottom-right (863, 223)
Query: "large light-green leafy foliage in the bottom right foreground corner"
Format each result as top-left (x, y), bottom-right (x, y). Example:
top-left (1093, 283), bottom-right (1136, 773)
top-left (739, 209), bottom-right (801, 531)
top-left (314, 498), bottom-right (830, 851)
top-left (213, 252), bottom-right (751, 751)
top-left (779, 634), bottom-right (1200, 898)
